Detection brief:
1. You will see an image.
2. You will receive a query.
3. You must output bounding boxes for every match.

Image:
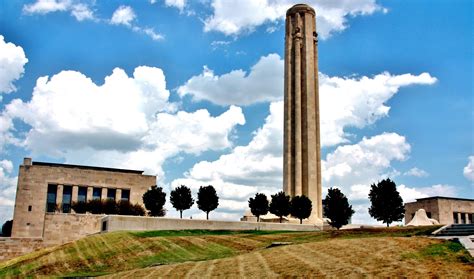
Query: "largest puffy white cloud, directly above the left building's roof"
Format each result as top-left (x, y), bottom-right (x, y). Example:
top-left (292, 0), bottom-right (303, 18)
top-left (0, 66), bottom-right (245, 178)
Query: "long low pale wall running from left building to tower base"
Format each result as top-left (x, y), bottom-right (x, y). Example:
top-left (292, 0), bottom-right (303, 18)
top-left (101, 215), bottom-right (322, 232)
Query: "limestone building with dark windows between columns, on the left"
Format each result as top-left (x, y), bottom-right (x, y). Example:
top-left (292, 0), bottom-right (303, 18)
top-left (12, 158), bottom-right (156, 238)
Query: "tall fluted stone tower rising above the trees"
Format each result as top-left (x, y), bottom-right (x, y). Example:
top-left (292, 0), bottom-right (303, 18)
top-left (283, 4), bottom-right (322, 223)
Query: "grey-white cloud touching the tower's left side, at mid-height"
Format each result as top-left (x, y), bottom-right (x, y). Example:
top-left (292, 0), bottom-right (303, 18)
top-left (178, 54), bottom-right (284, 105)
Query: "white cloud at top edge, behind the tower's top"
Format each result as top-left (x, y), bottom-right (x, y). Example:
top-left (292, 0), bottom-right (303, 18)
top-left (204, 0), bottom-right (386, 39)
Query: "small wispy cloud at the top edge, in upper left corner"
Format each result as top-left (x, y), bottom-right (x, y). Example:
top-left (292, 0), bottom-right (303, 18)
top-left (23, 0), bottom-right (95, 21)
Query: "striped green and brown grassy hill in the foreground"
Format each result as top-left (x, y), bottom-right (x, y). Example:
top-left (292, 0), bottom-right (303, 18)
top-left (0, 227), bottom-right (474, 278)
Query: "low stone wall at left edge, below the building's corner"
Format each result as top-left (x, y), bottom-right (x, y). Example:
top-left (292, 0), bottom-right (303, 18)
top-left (0, 237), bottom-right (44, 262)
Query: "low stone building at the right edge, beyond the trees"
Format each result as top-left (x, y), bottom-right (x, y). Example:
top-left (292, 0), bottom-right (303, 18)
top-left (405, 197), bottom-right (474, 225)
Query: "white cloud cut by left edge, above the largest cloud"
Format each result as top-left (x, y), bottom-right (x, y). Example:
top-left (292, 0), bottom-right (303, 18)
top-left (0, 35), bottom-right (28, 96)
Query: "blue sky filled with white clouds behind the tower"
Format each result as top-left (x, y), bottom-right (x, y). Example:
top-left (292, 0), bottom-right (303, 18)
top-left (0, 0), bottom-right (474, 223)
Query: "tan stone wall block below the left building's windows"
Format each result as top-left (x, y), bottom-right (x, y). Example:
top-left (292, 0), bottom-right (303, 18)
top-left (43, 213), bottom-right (104, 246)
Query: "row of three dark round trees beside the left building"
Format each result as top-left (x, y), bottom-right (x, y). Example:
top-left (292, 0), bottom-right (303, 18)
top-left (143, 185), bottom-right (219, 219)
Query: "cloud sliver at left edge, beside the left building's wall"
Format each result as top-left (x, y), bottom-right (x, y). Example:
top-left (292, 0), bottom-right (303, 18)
top-left (0, 160), bottom-right (17, 224)
